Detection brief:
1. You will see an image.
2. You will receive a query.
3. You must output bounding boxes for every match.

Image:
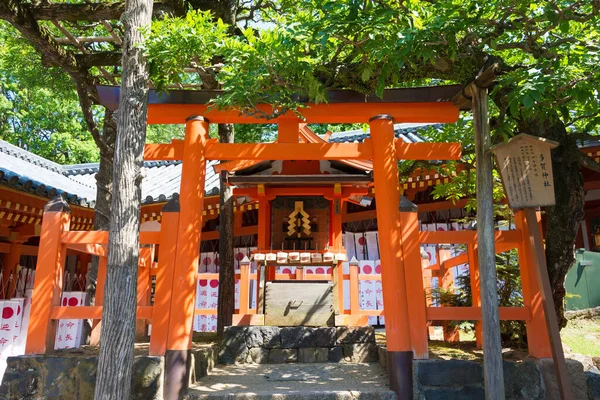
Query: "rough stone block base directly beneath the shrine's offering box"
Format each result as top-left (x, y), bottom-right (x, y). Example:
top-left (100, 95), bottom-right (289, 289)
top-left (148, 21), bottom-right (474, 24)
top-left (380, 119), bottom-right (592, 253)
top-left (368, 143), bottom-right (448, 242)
top-left (219, 326), bottom-right (378, 364)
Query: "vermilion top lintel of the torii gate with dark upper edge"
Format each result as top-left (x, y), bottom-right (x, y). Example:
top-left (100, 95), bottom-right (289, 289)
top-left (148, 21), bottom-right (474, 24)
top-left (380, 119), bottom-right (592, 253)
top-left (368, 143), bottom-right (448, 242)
top-left (98, 85), bottom-right (462, 124)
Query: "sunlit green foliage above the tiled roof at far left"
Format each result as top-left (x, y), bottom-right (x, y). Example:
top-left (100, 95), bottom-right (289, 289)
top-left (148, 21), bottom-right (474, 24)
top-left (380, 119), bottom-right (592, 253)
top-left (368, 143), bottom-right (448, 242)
top-left (0, 21), bottom-right (98, 164)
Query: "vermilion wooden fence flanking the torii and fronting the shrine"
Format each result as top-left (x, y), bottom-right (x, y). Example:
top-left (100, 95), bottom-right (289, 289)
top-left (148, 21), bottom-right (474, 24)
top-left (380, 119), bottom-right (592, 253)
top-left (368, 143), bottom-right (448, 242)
top-left (26, 195), bottom-right (550, 358)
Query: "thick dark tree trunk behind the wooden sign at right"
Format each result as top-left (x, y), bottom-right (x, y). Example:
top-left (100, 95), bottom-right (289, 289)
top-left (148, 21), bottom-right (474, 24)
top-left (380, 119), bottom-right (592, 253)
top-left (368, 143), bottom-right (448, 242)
top-left (522, 116), bottom-right (585, 328)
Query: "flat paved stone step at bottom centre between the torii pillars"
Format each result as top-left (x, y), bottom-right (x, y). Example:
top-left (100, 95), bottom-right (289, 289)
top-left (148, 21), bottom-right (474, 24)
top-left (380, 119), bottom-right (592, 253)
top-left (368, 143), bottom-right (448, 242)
top-left (185, 363), bottom-right (396, 400)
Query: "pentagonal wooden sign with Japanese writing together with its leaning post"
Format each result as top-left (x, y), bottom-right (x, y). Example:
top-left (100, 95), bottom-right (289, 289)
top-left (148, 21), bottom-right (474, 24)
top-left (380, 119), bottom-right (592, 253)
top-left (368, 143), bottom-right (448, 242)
top-left (492, 134), bottom-right (573, 400)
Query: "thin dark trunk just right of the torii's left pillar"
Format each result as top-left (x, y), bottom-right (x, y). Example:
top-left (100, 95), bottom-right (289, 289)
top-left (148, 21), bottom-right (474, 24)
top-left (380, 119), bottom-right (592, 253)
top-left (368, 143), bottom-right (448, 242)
top-left (217, 124), bottom-right (235, 336)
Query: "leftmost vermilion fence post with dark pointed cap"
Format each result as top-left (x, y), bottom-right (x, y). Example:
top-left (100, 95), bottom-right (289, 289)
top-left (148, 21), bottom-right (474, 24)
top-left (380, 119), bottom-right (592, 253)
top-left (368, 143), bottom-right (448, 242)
top-left (25, 196), bottom-right (71, 354)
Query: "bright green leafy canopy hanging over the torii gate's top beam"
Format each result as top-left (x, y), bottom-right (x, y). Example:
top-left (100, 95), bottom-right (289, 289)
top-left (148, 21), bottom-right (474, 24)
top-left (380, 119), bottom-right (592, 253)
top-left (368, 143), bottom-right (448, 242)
top-left (148, 0), bottom-right (600, 134)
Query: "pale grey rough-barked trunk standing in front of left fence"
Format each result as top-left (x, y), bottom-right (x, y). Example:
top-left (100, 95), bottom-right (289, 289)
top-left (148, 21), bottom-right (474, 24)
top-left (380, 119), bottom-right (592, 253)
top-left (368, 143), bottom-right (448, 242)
top-left (94, 0), bottom-right (152, 400)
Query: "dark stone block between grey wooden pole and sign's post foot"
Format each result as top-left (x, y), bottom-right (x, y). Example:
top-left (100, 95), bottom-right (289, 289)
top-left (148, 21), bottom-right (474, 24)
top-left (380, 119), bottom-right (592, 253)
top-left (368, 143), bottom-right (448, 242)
top-left (503, 361), bottom-right (546, 400)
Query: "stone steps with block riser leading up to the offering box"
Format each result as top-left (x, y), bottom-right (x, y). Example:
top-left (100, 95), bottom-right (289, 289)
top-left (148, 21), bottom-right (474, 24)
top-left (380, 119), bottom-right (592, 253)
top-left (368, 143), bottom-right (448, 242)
top-left (185, 327), bottom-right (396, 400)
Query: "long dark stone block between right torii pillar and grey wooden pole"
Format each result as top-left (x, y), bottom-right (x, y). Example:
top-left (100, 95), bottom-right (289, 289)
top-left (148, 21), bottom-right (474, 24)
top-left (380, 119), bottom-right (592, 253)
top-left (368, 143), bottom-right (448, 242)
top-left (416, 360), bottom-right (483, 386)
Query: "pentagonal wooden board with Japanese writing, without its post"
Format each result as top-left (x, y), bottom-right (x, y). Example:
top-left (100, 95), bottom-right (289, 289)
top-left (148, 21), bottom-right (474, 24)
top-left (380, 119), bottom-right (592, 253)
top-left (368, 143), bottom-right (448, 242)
top-left (492, 133), bottom-right (558, 209)
